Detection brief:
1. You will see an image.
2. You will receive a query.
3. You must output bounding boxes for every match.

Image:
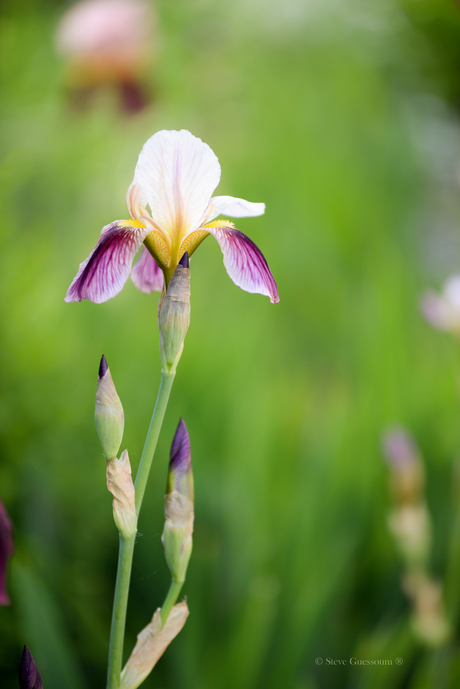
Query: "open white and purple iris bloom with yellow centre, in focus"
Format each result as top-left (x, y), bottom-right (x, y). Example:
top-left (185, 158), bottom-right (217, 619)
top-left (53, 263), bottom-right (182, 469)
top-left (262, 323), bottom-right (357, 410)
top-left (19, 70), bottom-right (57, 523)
top-left (66, 129), bottom-right (279, 304)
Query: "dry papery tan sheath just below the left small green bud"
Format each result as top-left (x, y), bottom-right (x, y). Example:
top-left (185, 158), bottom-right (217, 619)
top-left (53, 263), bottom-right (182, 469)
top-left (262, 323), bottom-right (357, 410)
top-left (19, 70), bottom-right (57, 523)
top-left (107, 450), bottom-right (137, 538)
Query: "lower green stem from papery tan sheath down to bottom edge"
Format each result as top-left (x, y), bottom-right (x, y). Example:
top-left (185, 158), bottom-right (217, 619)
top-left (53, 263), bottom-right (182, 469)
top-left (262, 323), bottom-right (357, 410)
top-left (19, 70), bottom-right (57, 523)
top-left (107, 534), bottom-right (136, 689)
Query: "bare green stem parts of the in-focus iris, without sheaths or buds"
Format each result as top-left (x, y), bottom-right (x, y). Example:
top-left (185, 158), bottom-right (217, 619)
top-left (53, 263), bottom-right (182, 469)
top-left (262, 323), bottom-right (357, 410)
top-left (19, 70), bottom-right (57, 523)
top-left (107, 371), bottom-right (176, 689)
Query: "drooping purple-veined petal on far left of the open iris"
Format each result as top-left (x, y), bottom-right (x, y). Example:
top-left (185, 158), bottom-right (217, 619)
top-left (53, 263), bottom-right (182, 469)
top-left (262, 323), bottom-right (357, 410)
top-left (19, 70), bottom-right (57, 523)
top-left (65, 220), bottom-right (150, 304)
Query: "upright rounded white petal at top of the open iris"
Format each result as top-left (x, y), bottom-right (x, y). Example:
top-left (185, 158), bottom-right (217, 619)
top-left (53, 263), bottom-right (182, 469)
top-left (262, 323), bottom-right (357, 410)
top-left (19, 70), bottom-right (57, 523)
top-left (133, 129), bottom-right (220, 236)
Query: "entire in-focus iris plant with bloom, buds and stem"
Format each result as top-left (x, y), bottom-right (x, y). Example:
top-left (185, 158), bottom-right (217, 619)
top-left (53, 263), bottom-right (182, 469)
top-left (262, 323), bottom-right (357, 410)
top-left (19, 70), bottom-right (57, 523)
top-left (66, 130), bottom-right (279, 689)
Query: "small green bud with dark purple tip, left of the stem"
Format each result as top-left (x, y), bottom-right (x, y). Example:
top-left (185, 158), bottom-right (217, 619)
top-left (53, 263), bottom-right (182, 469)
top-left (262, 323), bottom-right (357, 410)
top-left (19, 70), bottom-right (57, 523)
top-left (95, 356), bottom-right (125, 459)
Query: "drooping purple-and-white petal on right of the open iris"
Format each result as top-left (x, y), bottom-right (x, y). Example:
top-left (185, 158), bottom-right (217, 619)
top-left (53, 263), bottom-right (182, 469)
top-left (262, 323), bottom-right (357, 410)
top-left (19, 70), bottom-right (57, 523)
top-left (205, 227), bottom-right (280, 304)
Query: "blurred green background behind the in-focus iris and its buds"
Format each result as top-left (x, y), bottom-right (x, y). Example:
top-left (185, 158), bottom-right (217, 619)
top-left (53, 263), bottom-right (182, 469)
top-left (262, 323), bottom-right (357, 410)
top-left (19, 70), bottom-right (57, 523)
top-left (0, 0), bottom-right (460, 689)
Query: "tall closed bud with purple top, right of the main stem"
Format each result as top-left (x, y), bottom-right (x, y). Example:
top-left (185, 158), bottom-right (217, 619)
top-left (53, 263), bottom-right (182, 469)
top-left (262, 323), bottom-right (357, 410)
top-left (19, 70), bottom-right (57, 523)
top-left (162, 419), bottom-right (194, 582)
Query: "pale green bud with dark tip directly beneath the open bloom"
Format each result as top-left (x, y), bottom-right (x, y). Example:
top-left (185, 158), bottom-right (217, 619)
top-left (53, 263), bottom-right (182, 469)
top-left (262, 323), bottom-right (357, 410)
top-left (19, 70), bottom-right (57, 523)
top-left (158, 252), bottom-right (190, 371)
